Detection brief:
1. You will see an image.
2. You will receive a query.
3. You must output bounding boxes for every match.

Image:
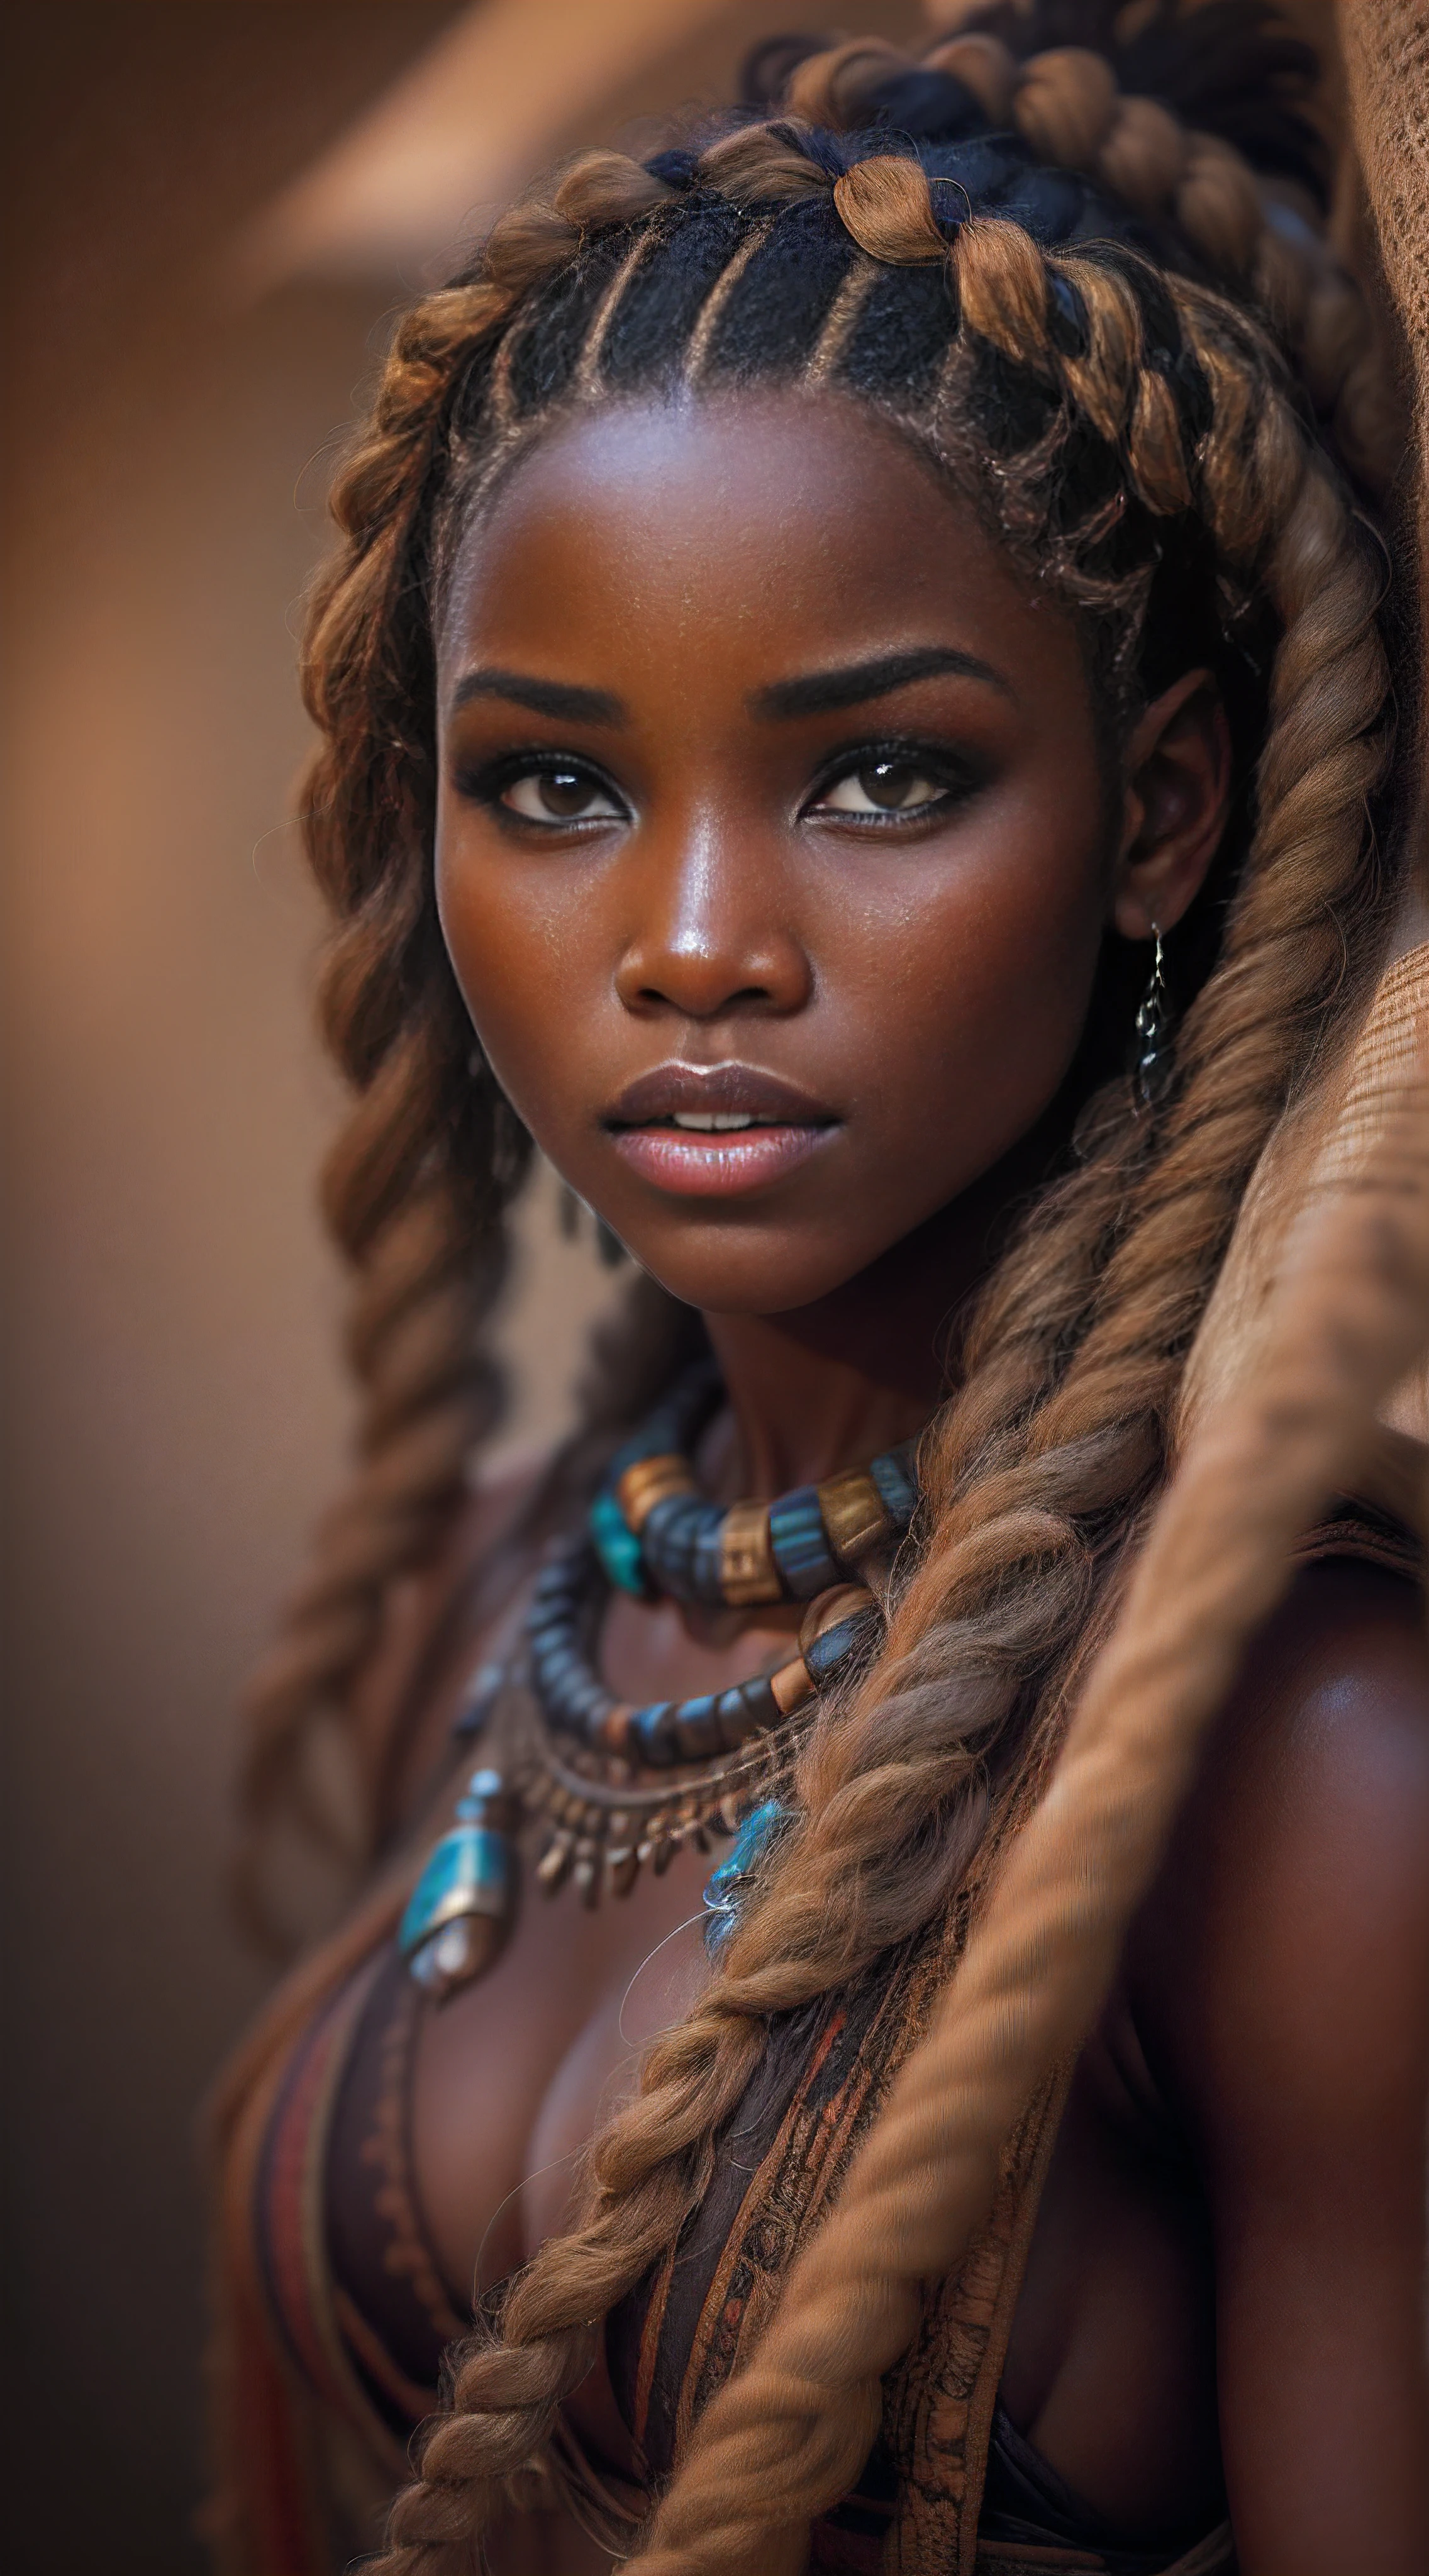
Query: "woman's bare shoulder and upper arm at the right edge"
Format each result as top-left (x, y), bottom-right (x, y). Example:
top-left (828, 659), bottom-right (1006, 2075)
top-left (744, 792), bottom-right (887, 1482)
top-left (1128, 1561), bottom-right (1429, 2576)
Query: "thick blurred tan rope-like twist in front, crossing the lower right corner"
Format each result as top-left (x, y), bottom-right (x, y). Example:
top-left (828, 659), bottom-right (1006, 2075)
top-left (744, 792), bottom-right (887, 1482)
top-left (630, 1062), bottom-right (1429, 2576)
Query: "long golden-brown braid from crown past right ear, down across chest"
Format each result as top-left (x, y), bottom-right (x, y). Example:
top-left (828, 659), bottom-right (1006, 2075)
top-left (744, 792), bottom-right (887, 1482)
top-left (363, 141), bottom-right (1385, 2576)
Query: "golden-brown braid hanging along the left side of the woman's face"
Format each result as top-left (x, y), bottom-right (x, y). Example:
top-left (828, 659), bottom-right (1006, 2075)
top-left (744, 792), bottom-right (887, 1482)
top-left (240, 152), bottom-right (669, 1937)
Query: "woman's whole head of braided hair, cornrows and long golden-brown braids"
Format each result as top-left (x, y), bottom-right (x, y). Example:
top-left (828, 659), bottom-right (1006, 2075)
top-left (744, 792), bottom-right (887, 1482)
top-left (250, 0), bottom-right (1396, 2576)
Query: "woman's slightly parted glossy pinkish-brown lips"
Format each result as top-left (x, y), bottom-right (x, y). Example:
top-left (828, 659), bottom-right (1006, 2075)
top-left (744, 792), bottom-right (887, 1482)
top-left (603, 1064), bottom-right (840, 1198)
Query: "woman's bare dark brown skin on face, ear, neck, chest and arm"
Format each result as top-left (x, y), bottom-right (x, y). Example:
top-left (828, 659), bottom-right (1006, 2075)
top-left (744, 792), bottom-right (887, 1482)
top-left (396, 397), bottom-right (1429, 2576)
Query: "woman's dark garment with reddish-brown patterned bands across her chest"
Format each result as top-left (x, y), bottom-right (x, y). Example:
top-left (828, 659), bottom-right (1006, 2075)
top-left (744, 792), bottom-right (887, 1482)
top-left (226, 1507), bottom-right (1421, 2576)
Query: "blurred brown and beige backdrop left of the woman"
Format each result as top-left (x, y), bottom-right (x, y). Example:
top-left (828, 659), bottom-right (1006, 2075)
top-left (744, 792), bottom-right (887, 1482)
top-left (0, 0), bottom-right (919, 2576)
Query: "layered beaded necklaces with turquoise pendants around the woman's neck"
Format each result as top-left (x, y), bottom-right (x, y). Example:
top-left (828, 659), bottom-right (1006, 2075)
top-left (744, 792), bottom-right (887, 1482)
top-left (396, 1363), bottom-right (919, 1999)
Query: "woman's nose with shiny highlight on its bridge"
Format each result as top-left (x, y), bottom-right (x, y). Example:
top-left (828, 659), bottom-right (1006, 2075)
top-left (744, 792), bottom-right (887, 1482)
top-left (615, 822), bottom-right (814, 1020)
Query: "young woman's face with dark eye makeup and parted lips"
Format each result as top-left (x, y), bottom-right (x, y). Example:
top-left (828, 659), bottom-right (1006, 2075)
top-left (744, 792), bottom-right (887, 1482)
top-left (438, 397), bottom-right (1115, 1314)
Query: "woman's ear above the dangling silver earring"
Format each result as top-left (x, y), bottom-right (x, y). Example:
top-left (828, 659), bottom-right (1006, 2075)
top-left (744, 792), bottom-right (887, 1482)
top-left (1112, 670), bottom-right (1231, 940)
